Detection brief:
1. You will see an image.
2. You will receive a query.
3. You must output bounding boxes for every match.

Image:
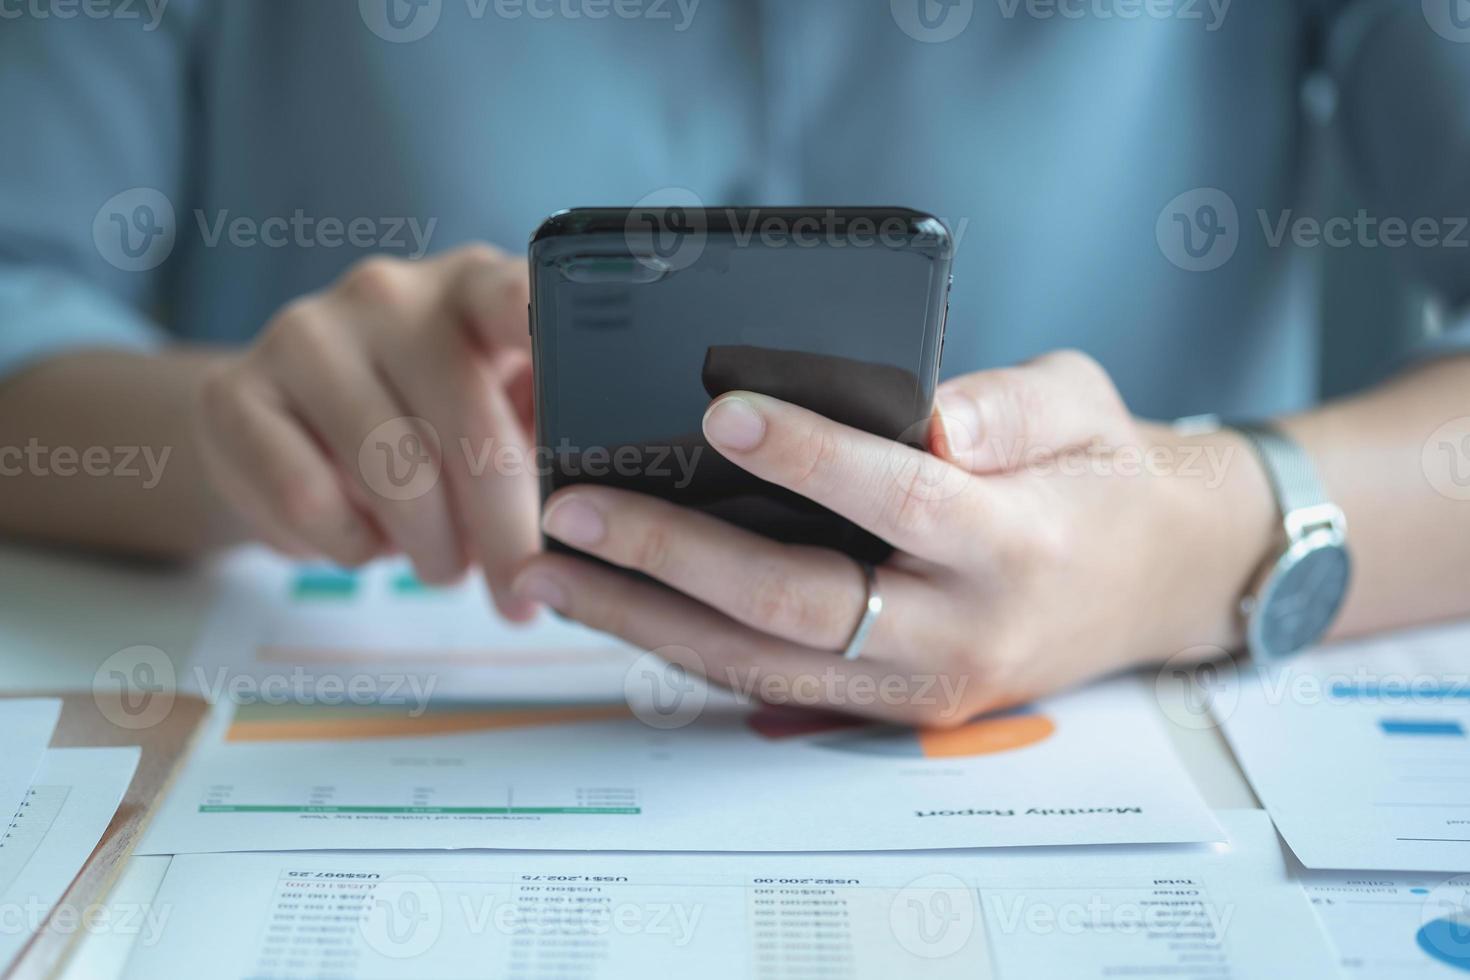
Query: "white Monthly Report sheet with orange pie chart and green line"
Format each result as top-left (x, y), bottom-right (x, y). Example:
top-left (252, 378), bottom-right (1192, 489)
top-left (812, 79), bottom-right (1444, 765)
top-left (140, 679), bottom-right (1220, 854)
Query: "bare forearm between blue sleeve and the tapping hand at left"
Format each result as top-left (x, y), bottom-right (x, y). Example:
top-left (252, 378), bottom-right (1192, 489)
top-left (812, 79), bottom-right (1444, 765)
top-left (0, 350), bottom-right (243, 558)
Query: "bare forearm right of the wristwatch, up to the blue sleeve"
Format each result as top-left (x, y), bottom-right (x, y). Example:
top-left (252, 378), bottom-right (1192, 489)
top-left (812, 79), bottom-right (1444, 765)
top-left (1283, 357), bottom-right (1470, 636)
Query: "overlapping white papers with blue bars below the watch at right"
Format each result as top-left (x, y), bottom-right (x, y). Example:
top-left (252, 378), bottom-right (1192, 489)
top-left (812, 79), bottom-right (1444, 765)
top-left (1216, 624), bottom-right (1470, 979)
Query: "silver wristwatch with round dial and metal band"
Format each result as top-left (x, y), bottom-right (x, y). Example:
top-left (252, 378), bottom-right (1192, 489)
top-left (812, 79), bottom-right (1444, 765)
top-left (1230, 423), bottom-right (1352, 660)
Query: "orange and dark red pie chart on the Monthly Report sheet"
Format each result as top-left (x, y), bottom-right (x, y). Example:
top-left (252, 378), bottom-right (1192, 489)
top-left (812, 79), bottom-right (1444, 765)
top-left (748, 708), bottom-right (1057, 758)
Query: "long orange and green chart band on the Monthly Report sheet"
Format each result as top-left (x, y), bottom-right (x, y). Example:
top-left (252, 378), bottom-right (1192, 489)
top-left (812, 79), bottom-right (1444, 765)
top-left (225, 702), bottom-right (631, 742)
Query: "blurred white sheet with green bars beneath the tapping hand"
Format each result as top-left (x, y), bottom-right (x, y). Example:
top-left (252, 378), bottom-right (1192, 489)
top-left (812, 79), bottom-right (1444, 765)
top-left (178, 548), bottom-right (638, 704)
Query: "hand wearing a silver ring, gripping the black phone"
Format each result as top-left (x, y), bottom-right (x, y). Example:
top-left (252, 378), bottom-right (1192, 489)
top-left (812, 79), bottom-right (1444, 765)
top-left (515, 351), bottom-right (1272, 726)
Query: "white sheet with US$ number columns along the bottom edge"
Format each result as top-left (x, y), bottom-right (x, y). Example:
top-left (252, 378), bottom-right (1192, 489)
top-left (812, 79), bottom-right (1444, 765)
top-left (126, 811), bottom-right (1336, 980)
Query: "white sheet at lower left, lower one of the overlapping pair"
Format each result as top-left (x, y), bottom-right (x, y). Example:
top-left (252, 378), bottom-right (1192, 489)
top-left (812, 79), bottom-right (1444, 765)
top-left (0, 746), bottom-right (140, 973)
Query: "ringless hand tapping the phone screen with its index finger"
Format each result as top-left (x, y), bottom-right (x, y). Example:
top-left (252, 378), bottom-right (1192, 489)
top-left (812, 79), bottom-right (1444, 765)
top-left (196, 245), bottom-right (539, 620)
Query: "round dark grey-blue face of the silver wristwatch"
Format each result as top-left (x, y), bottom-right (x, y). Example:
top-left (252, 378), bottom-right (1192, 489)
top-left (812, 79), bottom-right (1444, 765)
top-left (1250, 532), bottom-right (1352, 657)
